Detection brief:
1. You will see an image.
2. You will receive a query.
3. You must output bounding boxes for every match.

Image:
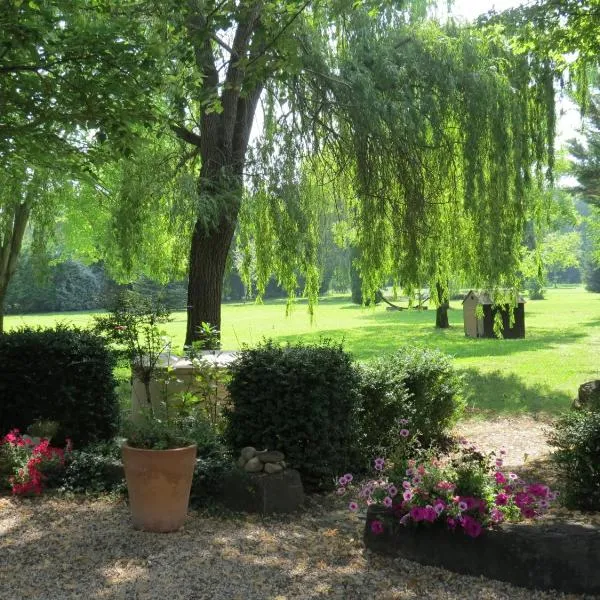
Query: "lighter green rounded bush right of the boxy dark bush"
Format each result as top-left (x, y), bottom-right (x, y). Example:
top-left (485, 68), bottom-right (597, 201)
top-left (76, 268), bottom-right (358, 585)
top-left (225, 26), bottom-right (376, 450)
top-left (360, 347), bottom-right (464, 454)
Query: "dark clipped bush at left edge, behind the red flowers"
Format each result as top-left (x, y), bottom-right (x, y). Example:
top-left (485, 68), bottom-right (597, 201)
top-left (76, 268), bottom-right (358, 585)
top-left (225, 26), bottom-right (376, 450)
top-left (0, 325), bottom-right (119, 448)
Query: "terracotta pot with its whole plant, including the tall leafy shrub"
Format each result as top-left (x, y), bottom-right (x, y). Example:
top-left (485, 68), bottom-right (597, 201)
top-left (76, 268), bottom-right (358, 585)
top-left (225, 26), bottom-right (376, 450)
top-left (96, 292), bottom-right (201, 532)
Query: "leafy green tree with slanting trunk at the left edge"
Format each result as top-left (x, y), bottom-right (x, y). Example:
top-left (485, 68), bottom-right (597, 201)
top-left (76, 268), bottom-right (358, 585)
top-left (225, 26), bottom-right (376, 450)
top-left (0, 0), bottom-right (162, 331)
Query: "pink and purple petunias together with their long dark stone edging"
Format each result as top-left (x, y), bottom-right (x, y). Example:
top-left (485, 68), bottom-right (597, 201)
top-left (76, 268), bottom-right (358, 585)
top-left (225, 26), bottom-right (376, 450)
top-left (338, 419), bottom-right (600, 593)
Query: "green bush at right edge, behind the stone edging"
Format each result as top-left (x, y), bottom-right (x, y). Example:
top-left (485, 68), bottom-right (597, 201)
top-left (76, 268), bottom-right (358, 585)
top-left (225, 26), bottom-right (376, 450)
top-left (549, 410), bottom-right (600, 510)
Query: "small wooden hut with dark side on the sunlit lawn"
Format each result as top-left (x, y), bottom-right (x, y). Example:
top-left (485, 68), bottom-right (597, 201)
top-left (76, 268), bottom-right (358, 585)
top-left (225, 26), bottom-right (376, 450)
top-left (463, 290), bottom-right (525, 338)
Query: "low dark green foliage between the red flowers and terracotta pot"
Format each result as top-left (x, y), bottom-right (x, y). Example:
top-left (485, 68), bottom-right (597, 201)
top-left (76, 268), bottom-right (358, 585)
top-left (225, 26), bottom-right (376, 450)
top-left (58, 440), bottom-right (125, 495)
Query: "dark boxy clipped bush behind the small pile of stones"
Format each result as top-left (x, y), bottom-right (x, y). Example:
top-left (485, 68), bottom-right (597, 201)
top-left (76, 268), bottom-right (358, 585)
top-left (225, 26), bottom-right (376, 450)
top-left (226, 341), bottom-right (358, 490)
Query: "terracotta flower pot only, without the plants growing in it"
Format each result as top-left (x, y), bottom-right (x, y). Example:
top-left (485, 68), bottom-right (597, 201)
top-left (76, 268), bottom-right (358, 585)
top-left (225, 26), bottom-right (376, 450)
top-left (122, 443), bottom-right (196, 532)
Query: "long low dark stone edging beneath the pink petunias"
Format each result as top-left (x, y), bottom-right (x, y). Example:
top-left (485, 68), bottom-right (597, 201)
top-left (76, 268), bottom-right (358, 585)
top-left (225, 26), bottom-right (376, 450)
top-left (364, 508), bottom-right (600, 594)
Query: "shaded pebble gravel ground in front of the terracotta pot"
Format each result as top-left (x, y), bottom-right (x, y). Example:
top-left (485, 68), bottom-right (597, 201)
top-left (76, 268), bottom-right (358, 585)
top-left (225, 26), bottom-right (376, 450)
top-left (0, 498), bottom-right (592, 600)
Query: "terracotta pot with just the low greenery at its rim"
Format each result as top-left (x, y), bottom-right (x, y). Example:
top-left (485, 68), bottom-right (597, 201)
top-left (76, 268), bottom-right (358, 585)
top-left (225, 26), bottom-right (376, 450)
top-left (122, 417), bottom-right (197, 532)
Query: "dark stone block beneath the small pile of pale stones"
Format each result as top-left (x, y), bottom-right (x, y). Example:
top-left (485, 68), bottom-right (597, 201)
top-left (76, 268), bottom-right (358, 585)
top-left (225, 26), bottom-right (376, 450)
top-left (221, 469), bottom-right (304, 514)
